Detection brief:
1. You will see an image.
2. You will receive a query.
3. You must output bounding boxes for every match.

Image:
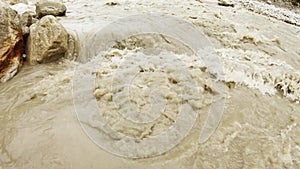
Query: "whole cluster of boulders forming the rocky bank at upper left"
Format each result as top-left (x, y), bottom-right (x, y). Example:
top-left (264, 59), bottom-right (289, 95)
top-left (0, 1), bottom-right (77, 82)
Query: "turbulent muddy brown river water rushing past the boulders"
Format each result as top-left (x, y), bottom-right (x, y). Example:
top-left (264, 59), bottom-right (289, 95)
top-left (0, 1), bottom-right (300, 169)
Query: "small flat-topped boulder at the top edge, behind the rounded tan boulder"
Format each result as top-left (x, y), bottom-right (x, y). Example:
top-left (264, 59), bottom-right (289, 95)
top-left (35, 1), bottom-right (67, 18)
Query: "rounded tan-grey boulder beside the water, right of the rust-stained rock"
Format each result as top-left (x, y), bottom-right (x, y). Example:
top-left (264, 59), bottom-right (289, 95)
top-left (26, 15), bottom-right (69, 65)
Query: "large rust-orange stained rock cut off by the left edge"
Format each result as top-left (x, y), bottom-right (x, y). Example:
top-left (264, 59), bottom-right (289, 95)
top-left (0, 2), bottom-right (24, 82)
